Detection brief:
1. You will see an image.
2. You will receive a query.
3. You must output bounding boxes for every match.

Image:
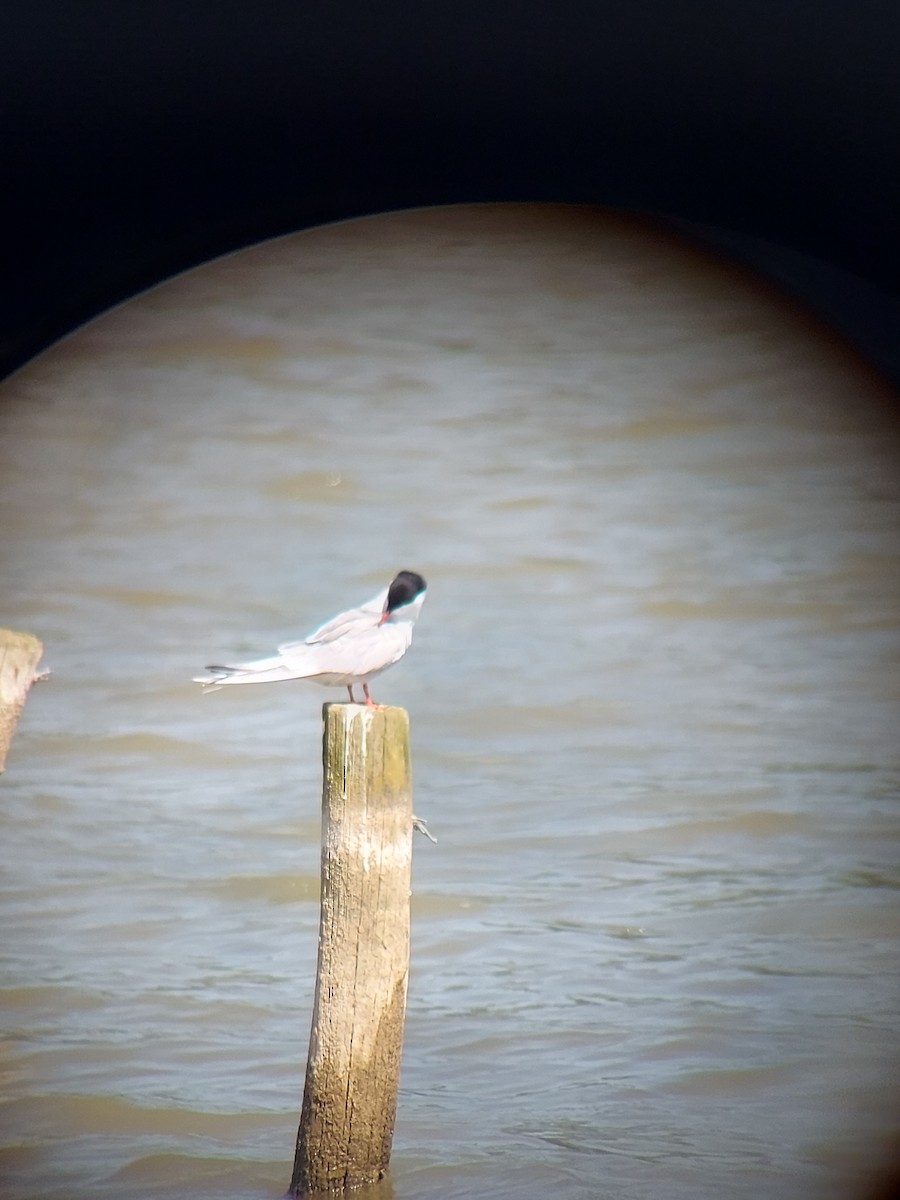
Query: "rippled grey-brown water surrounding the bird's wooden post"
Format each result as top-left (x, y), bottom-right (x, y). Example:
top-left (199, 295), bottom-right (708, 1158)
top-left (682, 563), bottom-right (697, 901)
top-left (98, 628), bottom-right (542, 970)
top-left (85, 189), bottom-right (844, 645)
top-left (0, 208), bottom-right (900, 1200)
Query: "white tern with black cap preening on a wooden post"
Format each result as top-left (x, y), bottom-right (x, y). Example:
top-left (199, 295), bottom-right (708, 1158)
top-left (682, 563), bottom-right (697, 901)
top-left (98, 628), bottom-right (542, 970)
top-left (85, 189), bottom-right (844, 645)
top-left (193, 571), bottom-right (425, 706)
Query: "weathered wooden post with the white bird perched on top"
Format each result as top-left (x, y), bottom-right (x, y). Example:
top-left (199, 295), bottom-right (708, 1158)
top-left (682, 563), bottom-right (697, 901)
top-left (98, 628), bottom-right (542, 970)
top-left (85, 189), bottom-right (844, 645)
top-left (288, 703), bottom-right (413, 1196)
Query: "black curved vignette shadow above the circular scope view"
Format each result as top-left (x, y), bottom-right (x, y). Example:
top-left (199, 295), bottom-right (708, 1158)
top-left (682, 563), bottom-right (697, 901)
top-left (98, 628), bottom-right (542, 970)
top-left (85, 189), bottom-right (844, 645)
top-left (7, 0), bottom-right (900, 380)
